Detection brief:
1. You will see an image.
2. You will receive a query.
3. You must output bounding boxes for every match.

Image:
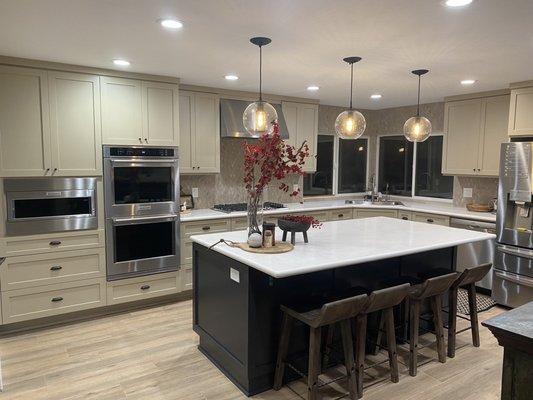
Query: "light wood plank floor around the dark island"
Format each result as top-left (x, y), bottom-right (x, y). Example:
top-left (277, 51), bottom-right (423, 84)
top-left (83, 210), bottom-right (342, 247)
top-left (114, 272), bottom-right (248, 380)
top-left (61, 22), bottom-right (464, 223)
top-left (0, 301), bottom-right (503, 400)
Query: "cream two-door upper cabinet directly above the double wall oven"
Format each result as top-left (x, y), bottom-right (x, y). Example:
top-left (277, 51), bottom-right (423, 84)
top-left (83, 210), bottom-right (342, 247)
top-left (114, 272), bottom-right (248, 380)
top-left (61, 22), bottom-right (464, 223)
top-left (100, 76), bottom-right (179, 146)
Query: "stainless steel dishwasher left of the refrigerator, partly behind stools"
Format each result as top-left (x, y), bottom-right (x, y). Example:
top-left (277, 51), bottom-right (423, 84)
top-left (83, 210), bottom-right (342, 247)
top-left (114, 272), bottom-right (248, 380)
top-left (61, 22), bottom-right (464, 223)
top-left (450, 218), bottom-right (496, 290)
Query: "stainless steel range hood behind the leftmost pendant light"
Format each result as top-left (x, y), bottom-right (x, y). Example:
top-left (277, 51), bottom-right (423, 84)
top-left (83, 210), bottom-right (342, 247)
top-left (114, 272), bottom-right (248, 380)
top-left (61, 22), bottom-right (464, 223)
top-left (220, 99), bottom-right (289, 139)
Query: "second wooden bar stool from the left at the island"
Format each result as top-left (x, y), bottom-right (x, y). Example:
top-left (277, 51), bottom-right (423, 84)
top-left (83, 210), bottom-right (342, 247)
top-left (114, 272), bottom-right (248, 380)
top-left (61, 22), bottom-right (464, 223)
top-left (355, 283), bottom-right (410, 398)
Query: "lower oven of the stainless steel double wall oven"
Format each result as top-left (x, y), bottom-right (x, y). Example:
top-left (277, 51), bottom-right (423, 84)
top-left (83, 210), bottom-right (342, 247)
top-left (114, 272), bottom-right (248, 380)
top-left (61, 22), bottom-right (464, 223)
top-left (106, 215), bottom-right (180, 280)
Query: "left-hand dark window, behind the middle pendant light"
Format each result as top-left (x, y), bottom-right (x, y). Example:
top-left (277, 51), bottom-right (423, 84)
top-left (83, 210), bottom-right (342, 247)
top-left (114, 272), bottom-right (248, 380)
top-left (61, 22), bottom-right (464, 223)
top-left (304, 135), bottom-right (368, 196)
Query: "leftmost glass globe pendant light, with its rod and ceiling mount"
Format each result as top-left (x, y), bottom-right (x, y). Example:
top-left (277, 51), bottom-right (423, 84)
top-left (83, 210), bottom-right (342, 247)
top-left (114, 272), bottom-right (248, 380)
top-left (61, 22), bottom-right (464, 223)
top-left (242, 37), bottom-right (278, 137)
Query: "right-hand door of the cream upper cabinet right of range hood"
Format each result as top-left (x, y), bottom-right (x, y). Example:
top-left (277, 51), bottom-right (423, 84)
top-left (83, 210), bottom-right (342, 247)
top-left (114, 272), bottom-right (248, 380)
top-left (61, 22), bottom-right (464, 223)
top-left (294, 104), bottom-right (318, 172)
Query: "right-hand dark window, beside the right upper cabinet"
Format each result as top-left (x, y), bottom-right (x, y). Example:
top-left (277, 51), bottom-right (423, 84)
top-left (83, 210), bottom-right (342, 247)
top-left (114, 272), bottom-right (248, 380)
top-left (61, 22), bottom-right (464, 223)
top-left (378, 135), bottom-right (453, 199)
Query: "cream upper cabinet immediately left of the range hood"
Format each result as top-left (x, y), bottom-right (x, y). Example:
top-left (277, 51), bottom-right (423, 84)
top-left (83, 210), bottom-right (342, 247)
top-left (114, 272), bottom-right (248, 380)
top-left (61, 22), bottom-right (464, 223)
top-left (179, 91), bottom-right (220, 174)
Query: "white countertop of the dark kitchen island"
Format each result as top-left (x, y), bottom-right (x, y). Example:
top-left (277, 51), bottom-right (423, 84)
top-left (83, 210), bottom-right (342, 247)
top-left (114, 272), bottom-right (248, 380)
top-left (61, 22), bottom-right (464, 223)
top-left (192, 217), bottom-right (496, 278)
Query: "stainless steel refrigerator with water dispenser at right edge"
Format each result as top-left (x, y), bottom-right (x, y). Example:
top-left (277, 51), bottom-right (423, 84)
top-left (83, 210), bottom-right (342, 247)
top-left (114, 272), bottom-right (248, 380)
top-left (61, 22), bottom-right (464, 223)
top-left (492, 142), bottom-right (533, 307)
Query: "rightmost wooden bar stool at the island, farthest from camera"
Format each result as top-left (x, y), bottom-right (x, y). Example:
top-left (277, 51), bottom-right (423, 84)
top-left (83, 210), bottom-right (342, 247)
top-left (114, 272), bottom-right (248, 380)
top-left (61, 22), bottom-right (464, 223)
top-left (448, 263), bottom-right (492, 358)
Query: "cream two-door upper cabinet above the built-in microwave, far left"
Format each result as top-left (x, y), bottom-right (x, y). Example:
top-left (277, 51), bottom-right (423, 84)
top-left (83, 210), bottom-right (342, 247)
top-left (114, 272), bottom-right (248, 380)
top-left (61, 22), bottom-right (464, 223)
top-left (0, 66), bottom-right (102, 177)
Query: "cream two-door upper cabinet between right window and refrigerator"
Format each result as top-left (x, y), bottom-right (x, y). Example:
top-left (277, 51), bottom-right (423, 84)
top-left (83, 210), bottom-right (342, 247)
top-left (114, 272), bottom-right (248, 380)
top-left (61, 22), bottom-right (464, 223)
top-left (442, 95), bottom-right (509, 176)
